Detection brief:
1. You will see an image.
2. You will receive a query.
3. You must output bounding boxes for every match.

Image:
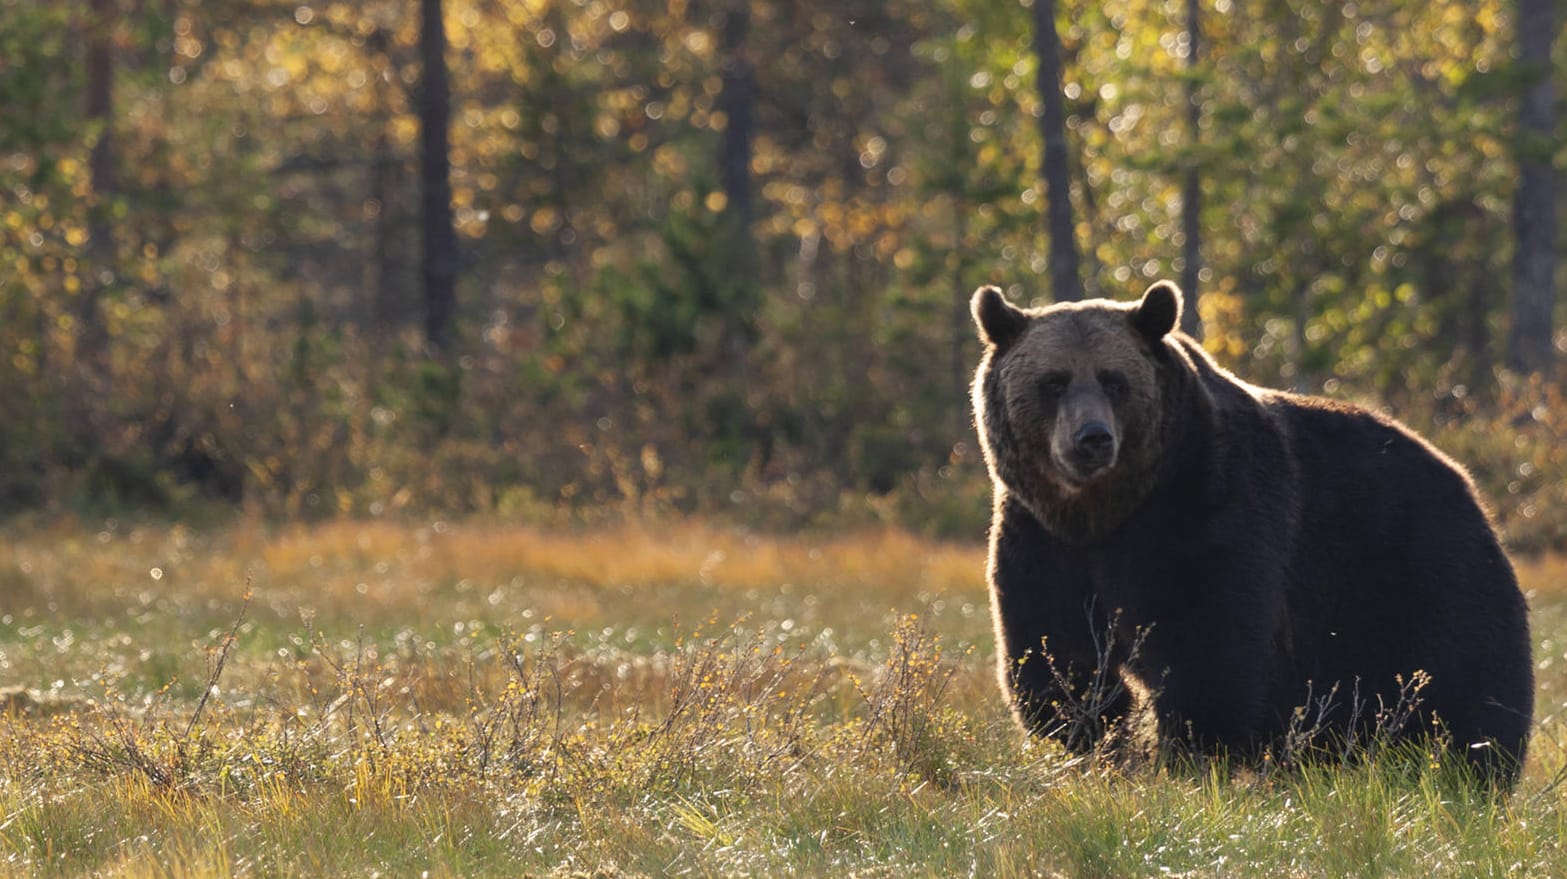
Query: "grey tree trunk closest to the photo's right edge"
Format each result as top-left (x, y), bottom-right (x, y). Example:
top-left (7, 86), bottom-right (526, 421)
top-left (1507, 0), bottom-right (1556, 373)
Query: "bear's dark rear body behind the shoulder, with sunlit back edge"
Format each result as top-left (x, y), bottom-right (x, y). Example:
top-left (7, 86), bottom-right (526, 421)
top-left (1263, 393), bottom-right (1531, 720)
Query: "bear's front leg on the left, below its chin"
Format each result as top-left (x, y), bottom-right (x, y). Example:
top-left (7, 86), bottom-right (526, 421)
top-left (990, 500), bottom-right (1131, 752)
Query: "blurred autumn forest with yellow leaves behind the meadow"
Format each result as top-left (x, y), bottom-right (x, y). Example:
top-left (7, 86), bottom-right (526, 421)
top-left (0, 0), bottom-right (1567, 547)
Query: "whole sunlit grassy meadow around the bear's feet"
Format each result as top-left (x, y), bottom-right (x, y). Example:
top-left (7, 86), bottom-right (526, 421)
top-left (0, 522), bottom-right (1567, 877)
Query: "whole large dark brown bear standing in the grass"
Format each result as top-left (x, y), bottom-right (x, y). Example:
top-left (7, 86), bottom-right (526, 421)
top-left (973, 282), bottom-right (1534, 785)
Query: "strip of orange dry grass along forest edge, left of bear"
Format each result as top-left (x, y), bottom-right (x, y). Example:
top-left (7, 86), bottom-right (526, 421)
top-left (0, 522), bottom-right (984, 627)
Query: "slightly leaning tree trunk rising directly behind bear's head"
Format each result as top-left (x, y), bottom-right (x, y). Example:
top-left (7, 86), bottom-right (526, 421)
top-left (1034, 0), bottom-right (1083, 302)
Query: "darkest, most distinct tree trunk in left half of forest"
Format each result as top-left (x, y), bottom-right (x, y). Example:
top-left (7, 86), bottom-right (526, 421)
top-left (418, 0), bottom-right (458, 356)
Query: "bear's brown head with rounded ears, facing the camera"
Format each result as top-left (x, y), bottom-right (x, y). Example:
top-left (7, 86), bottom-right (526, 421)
top-left (972, 280), bottom-right (1180, 539)
